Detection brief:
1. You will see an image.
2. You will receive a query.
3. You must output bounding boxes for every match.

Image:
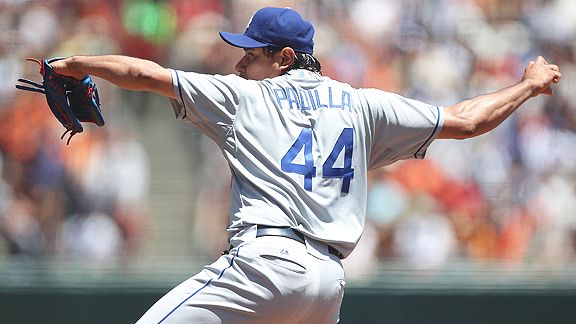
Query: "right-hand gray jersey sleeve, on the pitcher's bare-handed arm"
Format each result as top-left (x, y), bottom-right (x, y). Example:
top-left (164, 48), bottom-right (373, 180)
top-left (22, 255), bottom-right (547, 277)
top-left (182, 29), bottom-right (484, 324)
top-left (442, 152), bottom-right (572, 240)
top-left (360, 89), bottom-right (444, 169)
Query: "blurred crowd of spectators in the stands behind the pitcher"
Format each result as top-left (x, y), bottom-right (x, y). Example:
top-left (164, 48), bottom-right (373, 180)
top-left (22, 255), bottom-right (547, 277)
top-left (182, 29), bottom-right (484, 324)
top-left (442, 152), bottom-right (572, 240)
top-left (0, 0), bottom-right (576, 273)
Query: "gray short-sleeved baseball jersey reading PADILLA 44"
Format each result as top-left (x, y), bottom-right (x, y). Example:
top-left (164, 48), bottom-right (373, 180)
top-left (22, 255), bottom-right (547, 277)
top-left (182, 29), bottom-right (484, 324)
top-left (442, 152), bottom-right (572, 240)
top-left (171, 70), bottom-right (443, 256)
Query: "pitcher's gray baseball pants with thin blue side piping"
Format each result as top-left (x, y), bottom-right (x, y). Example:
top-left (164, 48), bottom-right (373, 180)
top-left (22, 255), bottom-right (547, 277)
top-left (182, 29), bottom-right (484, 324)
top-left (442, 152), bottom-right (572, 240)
top-left (137, 229), bottom-right (345, 324)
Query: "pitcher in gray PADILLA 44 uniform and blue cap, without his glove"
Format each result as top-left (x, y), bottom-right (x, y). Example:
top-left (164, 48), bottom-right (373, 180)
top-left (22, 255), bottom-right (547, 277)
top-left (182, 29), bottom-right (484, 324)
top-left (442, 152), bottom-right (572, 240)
top-left (39, 8), bottom-right (560, 324)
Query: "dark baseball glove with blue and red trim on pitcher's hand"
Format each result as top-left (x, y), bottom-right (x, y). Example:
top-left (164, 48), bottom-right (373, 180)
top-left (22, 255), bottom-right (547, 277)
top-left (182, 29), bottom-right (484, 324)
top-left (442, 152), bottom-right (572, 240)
top-left (16, 58), bottom-right (104, 144)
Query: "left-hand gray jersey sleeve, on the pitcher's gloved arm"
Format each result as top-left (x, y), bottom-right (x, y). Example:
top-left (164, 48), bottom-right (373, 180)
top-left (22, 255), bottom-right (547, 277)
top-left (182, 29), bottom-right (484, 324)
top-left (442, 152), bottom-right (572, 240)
top-left (170, 70), bottom-right (244, 146)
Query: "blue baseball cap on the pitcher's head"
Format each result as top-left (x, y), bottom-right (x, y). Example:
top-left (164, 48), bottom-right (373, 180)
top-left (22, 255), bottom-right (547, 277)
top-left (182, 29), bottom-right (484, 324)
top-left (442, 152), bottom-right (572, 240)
top-left (220, 7), bottom-right (314, 54)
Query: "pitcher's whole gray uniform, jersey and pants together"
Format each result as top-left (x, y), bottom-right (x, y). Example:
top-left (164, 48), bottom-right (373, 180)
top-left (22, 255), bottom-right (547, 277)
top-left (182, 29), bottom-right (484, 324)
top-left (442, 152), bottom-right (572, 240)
top-left (141, 70), bottom-right (443, 323)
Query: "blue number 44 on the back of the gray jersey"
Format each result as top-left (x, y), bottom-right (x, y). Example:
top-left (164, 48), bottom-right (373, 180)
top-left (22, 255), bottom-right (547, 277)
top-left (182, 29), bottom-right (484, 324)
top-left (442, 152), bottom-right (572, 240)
top-left (280, 128), bottom-right (354, 193)
